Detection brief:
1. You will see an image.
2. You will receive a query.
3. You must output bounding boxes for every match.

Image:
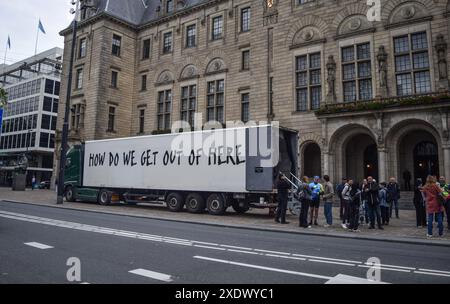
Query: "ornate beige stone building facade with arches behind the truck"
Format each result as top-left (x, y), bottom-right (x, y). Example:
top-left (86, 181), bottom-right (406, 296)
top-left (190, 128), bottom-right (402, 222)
top-left (54, 0), bottom-right (450, 188)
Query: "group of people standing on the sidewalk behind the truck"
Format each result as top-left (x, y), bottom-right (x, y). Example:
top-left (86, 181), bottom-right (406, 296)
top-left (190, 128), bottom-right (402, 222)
top-left (275, 173), bottom-right (450, 237)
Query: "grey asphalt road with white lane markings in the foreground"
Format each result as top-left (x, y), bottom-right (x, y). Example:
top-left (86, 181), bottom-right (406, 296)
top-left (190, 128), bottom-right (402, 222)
top-left (0, 202), bottom-right (450, 284)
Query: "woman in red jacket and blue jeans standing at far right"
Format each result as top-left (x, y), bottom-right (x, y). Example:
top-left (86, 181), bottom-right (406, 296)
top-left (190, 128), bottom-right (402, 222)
top-left (422, 176), bottom-right (444, 238)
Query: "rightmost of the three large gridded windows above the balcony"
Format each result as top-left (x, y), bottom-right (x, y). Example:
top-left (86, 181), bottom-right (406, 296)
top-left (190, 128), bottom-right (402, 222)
top-left (394, 32), bottom-right (431, 96)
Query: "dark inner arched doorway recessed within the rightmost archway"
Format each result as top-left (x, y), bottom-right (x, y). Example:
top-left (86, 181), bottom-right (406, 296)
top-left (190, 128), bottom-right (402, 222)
top-left (413, 141), bottom-right (439, 181)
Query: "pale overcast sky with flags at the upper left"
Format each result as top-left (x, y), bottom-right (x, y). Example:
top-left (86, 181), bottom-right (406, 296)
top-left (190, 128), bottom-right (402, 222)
top-left (0, 0), bottom-right (73, 64)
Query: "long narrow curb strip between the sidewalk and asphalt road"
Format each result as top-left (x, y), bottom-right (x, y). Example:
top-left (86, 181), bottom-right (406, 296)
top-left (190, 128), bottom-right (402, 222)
top-left (0, 199), bottom-right (450, 247)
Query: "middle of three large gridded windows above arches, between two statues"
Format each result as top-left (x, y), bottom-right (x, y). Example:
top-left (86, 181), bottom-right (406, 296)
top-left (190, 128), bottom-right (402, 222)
top-left (341, 43), bottom-right (373, 102)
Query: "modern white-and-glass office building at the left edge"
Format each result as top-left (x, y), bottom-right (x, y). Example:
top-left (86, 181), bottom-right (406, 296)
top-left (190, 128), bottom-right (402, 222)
top-left (0, 48), bottom-right (63, 186)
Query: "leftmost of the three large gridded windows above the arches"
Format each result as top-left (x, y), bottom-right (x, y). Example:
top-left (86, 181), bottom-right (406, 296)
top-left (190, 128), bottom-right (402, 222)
top-left (295, 53), bottom-right (322, 111)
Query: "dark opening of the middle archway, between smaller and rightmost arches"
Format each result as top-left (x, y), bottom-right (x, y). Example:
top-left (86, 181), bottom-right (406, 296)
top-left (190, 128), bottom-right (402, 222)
top-left (344, 134), bottom-right (378, 183)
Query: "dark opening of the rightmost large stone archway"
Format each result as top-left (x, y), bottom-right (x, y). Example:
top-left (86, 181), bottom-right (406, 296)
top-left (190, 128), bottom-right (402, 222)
top-left (398, 129), bottom-right (439, 185)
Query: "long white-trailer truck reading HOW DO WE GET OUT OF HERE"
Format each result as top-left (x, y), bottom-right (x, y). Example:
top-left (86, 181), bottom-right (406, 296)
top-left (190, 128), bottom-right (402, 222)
top-left (64, 124), bottom-right (298, 215)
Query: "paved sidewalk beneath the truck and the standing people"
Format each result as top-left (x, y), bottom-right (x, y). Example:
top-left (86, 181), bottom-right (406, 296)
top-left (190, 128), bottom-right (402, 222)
top-left (0, 188), bottom-right (450, 246)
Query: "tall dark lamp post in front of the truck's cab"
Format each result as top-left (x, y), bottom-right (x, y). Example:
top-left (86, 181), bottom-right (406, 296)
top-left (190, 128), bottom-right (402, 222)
top-left (56, 0), bottom-right (82, 205)
